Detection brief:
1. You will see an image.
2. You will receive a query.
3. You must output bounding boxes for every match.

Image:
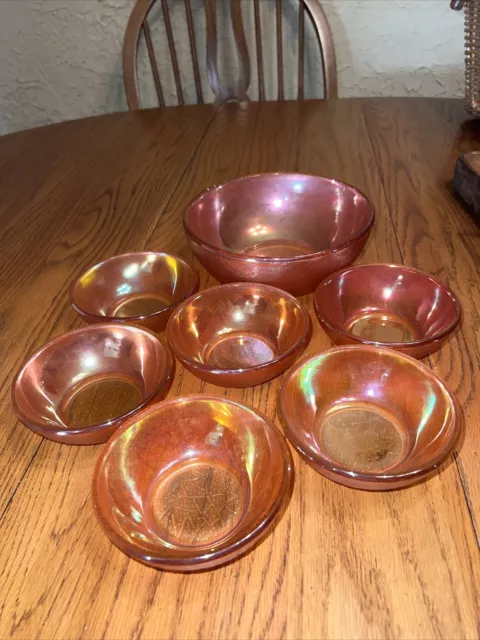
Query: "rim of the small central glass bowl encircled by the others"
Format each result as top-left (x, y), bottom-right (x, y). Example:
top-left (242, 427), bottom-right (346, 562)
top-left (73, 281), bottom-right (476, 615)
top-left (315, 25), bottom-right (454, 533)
top-left (165, 282), bottom-right (313, 376)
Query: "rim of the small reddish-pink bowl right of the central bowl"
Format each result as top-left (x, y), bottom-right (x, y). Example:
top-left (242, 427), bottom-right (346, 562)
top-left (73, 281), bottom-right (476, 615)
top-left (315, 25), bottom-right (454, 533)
top-left (313, 262), bottom-right (462, 348)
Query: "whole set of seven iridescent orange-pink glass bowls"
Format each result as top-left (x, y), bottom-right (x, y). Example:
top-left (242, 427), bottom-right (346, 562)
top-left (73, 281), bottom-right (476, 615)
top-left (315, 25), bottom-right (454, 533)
top-left (12, 174), bottom-right (461, 571)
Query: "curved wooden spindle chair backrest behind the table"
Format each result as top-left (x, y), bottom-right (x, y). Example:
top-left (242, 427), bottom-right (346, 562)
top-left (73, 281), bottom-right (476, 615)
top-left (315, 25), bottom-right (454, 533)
top-left (123, 0), bottom-right (337, 109)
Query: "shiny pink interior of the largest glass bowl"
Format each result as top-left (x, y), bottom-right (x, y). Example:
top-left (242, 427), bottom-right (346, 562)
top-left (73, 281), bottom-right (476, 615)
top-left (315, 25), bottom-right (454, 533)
top-left (185, 174), bottom-right (373, 258)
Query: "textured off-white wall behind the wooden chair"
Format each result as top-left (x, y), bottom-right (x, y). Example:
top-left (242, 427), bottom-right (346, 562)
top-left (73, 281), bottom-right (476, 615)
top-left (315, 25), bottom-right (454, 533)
top-left (0, 0), bottom-right (463, 133)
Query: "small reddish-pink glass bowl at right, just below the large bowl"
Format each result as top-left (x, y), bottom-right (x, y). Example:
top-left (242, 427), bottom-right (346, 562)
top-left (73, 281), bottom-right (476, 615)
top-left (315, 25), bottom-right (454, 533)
top-left (314, 264), bottom-right (461, 358)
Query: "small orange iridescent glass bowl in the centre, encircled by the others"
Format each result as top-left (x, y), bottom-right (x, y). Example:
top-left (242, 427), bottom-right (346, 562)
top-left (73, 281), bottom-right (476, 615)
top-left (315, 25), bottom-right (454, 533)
top-left (167, 282), bottom-right (312, 387)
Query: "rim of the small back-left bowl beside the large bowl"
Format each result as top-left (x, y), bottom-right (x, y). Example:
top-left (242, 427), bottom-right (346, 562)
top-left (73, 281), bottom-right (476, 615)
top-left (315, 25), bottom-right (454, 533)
top-left (68, 251), bottom-right (200, 324)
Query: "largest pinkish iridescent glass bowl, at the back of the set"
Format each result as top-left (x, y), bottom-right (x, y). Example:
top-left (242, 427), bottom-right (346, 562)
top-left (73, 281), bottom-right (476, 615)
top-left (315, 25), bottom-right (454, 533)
top-left (184, 173), bottom-right (374, 295)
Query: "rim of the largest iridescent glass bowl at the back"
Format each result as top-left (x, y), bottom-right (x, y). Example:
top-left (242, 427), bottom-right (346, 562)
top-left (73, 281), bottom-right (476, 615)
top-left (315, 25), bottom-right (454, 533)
top-left (183, 171), bottom-right (375, 264)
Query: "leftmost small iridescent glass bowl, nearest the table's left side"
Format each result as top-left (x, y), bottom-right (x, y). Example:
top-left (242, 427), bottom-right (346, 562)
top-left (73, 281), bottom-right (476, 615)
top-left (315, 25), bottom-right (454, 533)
top-left (11, 324), bottom-right (174, 444)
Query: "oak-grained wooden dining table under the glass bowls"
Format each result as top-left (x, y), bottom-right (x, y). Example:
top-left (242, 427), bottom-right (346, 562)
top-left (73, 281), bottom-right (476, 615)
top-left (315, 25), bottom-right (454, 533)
top-left (0, 99), bottom-right (480, 640)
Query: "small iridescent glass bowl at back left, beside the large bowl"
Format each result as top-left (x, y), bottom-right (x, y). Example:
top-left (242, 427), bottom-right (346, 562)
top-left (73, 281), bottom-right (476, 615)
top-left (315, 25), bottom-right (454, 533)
top-left (70, 251), bottom-right (198, 332)
